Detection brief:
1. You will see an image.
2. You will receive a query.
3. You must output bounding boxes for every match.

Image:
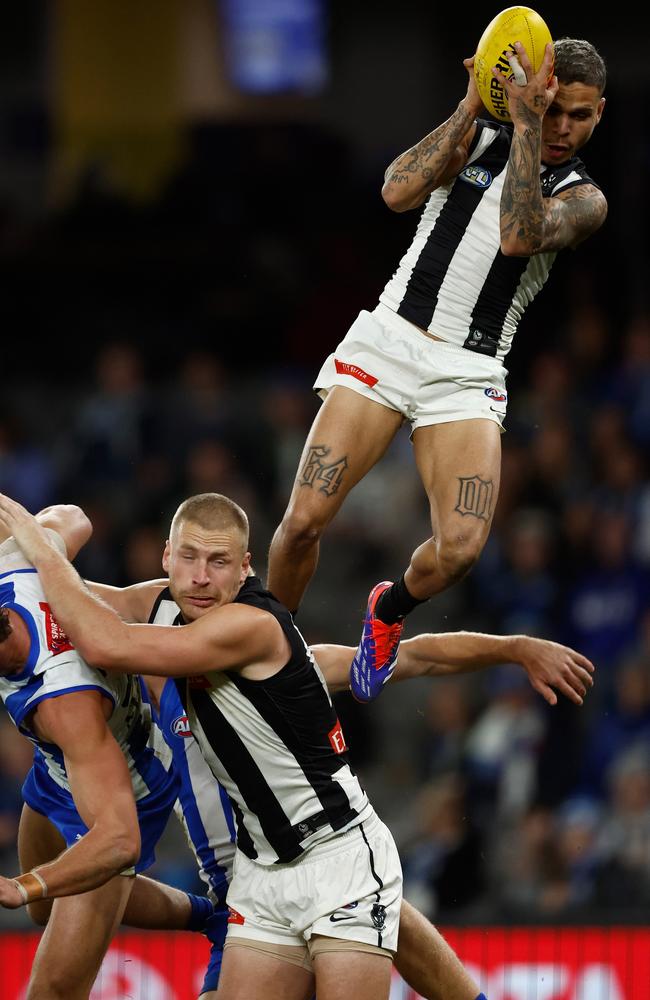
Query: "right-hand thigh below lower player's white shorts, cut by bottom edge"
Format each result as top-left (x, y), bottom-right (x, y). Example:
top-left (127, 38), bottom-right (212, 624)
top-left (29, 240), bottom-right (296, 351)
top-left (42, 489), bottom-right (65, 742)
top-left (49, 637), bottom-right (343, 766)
top-left (313, 950), bottom-right (392, 1000)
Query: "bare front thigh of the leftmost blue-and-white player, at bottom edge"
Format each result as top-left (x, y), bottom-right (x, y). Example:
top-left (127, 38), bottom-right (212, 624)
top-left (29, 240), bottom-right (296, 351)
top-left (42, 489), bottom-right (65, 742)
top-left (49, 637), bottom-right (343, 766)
top-left (25, 875), bottom-right (133, 1000)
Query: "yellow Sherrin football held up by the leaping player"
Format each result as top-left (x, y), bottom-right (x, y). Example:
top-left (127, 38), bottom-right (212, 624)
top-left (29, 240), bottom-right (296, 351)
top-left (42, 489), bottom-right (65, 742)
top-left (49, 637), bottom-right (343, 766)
top-left (474, 7), bottom-right (553, 122)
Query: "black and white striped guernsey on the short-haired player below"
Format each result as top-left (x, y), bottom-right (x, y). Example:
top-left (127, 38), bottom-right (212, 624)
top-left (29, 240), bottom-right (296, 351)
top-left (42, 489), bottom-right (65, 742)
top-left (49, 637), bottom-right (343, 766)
top-left (150, 577), bottom-right (373, 865)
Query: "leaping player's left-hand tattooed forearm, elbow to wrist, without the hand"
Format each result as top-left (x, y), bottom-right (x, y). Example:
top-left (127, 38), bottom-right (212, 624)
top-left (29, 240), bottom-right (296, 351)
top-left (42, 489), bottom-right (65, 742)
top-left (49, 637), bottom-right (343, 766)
top-left (381, 99), bottom-right (475, 212)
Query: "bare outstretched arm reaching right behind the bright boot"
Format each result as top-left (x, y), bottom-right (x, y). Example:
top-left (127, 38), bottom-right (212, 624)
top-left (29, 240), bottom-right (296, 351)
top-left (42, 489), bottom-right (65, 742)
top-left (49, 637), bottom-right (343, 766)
top-left (312, 632), bottom-right (594, 705)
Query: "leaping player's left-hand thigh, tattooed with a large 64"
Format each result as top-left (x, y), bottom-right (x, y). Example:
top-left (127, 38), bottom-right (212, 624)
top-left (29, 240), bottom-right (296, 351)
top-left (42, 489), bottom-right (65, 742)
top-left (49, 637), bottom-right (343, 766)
top-left (289, 386), bottom-right (402, 512)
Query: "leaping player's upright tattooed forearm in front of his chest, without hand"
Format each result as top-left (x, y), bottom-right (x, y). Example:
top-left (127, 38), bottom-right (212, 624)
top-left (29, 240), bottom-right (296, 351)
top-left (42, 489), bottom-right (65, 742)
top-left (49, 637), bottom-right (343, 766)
top-left (500, 111), bottom-right (545, 256)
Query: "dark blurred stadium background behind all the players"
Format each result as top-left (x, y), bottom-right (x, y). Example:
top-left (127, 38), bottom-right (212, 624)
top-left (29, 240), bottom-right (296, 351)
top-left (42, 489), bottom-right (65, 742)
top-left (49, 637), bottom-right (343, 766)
top-left (0, 0), bottom-right (650, 1000)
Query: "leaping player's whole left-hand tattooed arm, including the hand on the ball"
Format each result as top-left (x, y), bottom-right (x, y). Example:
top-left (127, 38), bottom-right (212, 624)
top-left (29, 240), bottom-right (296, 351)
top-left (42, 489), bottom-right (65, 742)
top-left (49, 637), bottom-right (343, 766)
top-left (381, 58), bottom-right (483, 212)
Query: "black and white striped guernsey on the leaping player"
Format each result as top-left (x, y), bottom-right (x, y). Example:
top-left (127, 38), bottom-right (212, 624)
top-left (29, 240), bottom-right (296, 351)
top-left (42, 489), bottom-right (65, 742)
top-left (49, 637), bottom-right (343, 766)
top-left (379, 120), bottom-right (598, 360)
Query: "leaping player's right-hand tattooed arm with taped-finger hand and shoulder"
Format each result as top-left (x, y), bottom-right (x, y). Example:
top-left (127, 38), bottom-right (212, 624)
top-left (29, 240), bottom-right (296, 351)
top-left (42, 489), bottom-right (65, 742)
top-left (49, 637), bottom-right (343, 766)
top-left (495, 46), bottom-right (607, 257)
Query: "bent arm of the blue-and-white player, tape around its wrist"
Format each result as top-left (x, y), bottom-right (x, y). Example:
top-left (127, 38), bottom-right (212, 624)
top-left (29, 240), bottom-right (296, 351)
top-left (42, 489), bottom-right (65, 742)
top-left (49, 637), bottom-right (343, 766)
top-left (0, 691), bottom-right (140, 909)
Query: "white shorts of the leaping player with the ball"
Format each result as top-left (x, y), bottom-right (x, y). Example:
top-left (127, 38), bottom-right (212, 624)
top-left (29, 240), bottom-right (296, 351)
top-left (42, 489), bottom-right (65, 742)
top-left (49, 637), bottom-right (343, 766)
top-left (314, 303), bottom-right (508, 430)
